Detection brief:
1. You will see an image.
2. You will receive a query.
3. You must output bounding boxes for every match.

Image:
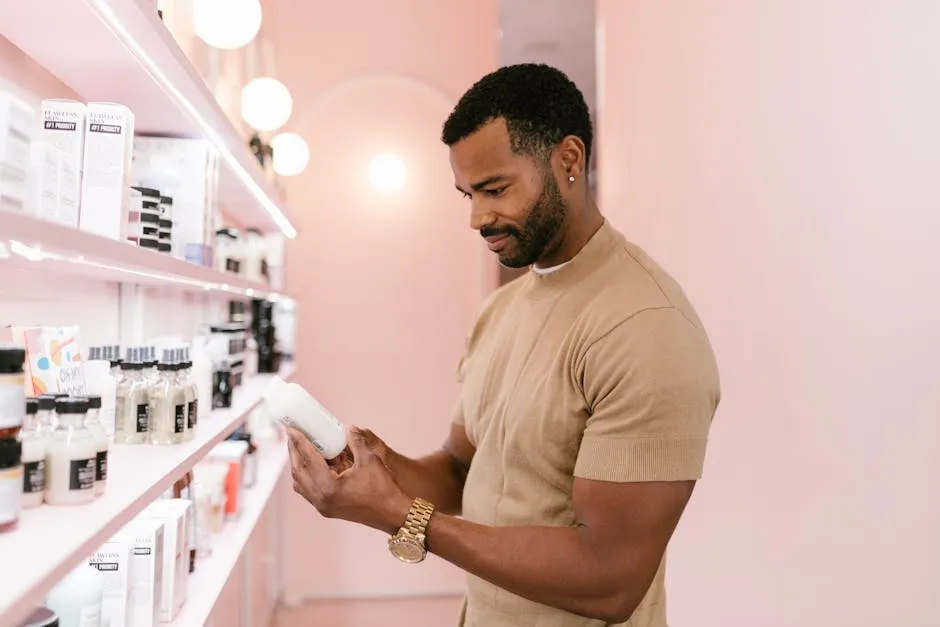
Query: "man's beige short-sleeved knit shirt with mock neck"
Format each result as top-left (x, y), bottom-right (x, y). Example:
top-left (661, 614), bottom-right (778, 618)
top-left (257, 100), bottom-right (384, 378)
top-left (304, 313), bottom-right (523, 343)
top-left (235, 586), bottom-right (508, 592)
top-left (454, 223), bottom-right (720, 627)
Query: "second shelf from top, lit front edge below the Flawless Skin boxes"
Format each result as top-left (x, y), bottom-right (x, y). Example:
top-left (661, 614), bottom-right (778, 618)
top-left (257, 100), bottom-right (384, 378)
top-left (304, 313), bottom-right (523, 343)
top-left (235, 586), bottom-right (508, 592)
top-left (0, 212), bottom-right (284, 298)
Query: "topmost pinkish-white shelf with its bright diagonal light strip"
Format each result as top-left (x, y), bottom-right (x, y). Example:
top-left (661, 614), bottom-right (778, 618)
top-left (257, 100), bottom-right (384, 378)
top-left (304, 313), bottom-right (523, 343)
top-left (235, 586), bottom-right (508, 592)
top-left (0, 0), bottom-right (296, 238)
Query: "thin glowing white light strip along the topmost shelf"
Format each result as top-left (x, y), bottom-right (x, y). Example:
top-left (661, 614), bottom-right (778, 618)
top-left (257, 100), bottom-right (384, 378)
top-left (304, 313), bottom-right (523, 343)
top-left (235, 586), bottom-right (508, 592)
top-left (85, 0), bottom-right (297, 239)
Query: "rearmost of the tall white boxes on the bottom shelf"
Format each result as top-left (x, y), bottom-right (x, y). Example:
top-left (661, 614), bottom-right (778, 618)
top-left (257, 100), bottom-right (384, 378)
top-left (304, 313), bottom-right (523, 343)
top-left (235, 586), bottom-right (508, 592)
top-left (141, 499), bottom-right (192, 623)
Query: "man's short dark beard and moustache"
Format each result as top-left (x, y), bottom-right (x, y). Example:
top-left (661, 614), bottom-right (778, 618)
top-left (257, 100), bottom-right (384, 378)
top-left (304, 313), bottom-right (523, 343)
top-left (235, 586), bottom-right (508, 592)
top-left (480, 171), bottom-right (568, 268)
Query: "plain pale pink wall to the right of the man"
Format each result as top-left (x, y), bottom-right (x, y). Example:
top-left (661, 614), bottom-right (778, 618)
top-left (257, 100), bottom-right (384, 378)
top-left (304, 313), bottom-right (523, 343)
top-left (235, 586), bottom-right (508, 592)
top-left (598, 0), bottom-right (940, 627)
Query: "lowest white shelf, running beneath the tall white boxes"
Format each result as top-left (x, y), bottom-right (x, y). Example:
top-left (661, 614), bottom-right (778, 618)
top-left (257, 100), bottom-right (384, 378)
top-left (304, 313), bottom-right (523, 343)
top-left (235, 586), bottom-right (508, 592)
top-left (170, 442), bottom-right (289, 627)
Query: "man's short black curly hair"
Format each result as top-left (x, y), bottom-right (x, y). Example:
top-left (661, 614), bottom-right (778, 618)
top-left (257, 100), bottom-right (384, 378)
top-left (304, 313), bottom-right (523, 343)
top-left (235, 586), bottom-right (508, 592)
top-left (441, 63), bottom-right (594, 169)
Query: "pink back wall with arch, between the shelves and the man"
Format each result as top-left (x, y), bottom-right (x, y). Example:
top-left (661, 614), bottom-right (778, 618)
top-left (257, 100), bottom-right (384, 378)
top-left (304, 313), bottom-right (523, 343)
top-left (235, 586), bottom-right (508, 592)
top-left (274, 0), bottom-right (498, 600)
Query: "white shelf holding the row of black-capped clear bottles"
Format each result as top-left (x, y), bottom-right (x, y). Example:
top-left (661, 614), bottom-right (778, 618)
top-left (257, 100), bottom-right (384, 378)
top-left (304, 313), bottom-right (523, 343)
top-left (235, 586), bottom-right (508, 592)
top-left (0, 366), bottom-right (293, 626)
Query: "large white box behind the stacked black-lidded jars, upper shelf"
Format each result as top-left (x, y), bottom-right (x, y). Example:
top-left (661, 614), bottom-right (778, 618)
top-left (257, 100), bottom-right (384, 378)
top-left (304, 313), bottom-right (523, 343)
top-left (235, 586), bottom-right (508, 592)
top-left (131, 137), bottom-right (219, 266)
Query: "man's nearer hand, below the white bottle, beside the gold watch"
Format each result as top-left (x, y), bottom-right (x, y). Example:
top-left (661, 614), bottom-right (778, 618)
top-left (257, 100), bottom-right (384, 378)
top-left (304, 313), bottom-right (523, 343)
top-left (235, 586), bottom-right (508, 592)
top-left (287, 427), bottom-right (411, 534)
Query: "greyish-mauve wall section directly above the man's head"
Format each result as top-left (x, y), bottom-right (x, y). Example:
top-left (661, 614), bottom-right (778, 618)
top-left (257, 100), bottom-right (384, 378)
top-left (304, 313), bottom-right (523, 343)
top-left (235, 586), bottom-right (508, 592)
top-left (499, 0), bottom-right (597, 115)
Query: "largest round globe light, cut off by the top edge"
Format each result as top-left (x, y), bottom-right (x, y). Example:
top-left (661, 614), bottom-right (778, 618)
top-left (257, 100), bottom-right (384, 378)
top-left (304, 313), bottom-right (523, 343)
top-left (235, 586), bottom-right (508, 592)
top-left (193, 0), bottom-right (261, 50)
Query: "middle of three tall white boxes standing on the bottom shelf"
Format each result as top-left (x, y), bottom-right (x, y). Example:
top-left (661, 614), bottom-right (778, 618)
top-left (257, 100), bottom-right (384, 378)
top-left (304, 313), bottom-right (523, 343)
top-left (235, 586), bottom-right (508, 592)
top-left (115, 518), bottom-right (164, 627)
